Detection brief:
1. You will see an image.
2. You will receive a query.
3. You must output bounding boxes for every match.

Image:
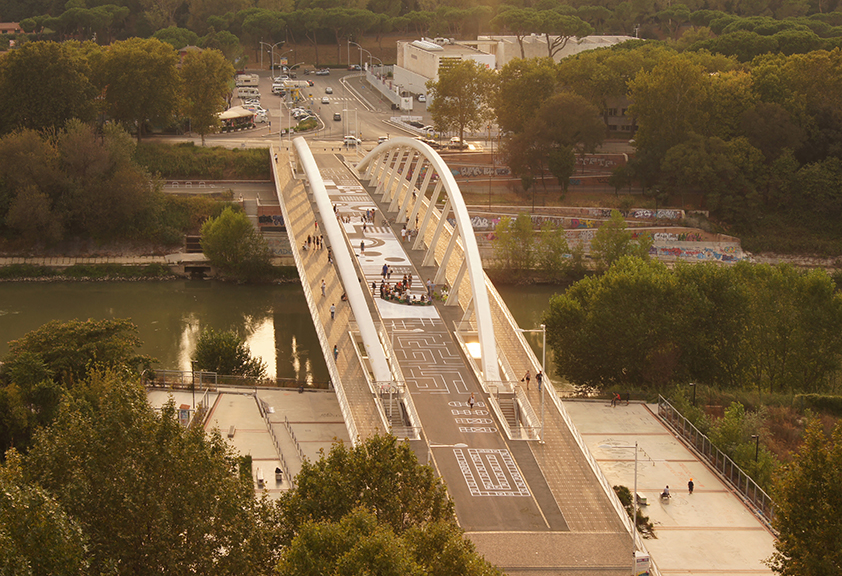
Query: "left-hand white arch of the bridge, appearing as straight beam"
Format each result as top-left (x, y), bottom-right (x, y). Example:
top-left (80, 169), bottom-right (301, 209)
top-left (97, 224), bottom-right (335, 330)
top-left (292, 136), bottom-right (392, 382)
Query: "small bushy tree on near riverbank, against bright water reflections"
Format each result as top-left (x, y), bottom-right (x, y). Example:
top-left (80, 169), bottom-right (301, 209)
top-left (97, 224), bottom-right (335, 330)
top-left (193, 328), bottom-right (266, 379)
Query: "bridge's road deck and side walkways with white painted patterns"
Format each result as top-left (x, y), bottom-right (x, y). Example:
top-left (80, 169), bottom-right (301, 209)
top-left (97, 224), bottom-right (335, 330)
top-left (272, 154), bottom-right (631, 576)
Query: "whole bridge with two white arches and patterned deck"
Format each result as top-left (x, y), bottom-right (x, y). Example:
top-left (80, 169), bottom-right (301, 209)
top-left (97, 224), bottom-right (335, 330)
top-left (271, 138), bottom-right (644, 576)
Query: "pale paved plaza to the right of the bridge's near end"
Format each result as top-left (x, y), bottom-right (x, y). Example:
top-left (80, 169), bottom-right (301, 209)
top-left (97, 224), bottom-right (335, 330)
top-left (564, 401), bottom-right (774, 576)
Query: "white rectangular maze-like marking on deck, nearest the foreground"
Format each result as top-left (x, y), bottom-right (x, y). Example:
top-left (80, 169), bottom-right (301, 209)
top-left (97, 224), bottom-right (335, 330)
top-left (453, 448), bottom-right (530, 496)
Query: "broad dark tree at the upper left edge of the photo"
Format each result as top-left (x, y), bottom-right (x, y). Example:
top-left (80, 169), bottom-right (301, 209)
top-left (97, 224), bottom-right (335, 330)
top-left (0, 42), bottom-right (97, 133)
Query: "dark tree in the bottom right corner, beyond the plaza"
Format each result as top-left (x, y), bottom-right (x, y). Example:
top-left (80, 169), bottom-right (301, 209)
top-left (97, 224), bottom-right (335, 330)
top-left (770, 421), bottom-right (842, 576)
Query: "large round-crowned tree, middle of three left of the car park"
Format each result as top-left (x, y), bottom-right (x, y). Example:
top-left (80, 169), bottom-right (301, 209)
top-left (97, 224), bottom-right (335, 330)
top-left (95, 38), bottom-right (181, 141)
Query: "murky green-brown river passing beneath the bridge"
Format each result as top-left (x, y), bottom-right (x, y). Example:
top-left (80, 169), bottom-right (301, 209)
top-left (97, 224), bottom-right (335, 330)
top-left (0, 280), bottom-right (561, 385)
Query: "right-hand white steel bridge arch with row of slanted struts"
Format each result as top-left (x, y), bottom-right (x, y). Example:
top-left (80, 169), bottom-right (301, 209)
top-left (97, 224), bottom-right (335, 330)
top-left (357, 137), bottom-right (500, 382)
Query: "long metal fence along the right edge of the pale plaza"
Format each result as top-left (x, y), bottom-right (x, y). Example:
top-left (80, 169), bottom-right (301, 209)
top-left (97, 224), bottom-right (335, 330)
top-left (658, 395), bottom-right (775, 528)
